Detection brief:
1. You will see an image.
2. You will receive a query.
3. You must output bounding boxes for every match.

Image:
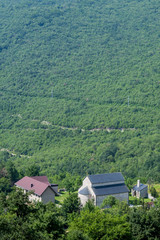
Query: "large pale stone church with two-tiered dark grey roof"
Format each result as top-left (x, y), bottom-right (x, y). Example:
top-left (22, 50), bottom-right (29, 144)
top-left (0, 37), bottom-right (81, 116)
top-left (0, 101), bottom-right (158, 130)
top-left (78, 172), bottom-right (129, 206)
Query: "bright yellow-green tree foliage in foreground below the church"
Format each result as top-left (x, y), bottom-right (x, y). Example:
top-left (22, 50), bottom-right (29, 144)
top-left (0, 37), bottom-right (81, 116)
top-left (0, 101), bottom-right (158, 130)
top-left (70, 208), bottom-right (131, 240)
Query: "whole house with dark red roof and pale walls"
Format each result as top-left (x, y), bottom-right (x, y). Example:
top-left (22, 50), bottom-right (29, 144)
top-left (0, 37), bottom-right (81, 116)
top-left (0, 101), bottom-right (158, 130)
top-left (15, 176), bottom-right (58, 204)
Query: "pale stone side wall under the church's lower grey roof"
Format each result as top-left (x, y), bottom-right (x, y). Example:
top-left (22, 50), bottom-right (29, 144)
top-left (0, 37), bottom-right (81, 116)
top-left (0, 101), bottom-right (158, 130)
top-left (96, 192), bottom-right (129, 206)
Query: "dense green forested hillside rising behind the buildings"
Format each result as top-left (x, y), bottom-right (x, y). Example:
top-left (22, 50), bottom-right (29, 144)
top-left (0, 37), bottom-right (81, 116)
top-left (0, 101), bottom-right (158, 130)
top-left (0, 0), bottom-right (160, 183)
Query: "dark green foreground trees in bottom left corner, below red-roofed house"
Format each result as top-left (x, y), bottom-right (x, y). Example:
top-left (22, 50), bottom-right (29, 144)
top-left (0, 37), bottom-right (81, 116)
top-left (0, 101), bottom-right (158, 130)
top-left (0, 190), bottom-right (64, 240)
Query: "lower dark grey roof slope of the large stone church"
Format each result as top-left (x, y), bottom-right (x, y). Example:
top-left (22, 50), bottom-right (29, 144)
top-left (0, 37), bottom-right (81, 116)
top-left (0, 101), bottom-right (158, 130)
top-left (92, 184), bottom-right (129, 196)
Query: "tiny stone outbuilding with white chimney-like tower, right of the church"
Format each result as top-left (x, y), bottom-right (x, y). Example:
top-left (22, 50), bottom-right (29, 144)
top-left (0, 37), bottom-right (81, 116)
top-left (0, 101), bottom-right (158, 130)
top-left (131, 180), bottom-right (148, 198)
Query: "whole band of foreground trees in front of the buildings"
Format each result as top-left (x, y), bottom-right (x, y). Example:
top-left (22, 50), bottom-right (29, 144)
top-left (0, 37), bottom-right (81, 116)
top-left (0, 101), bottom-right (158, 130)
top-left (0, 190), bottom-right (160, 240)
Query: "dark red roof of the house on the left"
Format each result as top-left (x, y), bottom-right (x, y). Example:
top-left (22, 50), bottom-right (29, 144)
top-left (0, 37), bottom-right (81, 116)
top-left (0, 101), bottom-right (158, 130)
top-left (15, 176), bottom-right (53, 196)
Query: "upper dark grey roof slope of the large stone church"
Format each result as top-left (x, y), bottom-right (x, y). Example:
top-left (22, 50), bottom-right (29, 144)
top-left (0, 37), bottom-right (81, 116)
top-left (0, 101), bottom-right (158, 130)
top-left (88, 172), bottom-right (124, 184)
